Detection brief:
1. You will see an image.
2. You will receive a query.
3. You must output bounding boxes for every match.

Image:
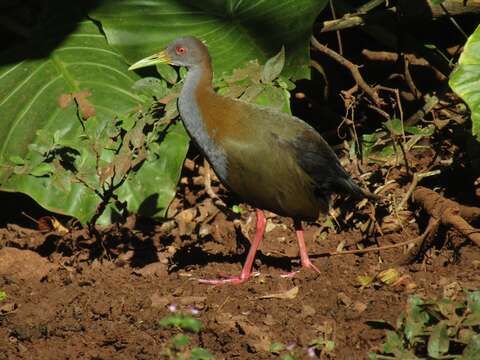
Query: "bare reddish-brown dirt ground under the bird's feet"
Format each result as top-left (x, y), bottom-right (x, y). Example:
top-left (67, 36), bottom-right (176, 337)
top-left (0, 148), bottom-right (480, 359)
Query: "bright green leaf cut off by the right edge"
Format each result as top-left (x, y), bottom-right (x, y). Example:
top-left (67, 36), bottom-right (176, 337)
top-left (449, 26), bottom-right (480, 141)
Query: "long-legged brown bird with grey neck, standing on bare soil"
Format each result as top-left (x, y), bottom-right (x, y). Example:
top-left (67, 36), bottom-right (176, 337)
top-left (129, 36), bottom-right (377, 285)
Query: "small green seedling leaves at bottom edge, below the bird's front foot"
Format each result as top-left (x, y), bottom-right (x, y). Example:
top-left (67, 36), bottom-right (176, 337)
top-left (159, 314), bottom-right (214, 360)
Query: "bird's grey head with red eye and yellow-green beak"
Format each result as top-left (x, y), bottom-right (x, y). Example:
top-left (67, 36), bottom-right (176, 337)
top-left (128, 36), bottom-right (210, 70)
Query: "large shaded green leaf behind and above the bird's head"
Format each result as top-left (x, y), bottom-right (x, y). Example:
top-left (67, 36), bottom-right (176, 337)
top-left (91, 0), bottom-right (327, 79)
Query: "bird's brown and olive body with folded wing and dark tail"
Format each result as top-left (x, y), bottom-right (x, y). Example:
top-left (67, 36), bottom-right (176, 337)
top-left (189, 87), bottom-right (370, 219)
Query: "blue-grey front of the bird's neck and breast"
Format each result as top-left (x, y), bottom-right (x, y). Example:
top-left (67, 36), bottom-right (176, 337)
top-left (178, 65), bottom-right (227, 181)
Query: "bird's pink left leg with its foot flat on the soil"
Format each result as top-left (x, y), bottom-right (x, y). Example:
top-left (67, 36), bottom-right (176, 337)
top-left (199, 209), bottom-right (266, 285)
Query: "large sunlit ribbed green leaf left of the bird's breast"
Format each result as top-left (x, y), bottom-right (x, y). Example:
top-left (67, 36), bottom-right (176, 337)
top-left (0, 17), bottom-right (188, 222)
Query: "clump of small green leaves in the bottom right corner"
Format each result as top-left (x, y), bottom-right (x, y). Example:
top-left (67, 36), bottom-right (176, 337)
top-left (369, 290), bottom-right (480, 360)
